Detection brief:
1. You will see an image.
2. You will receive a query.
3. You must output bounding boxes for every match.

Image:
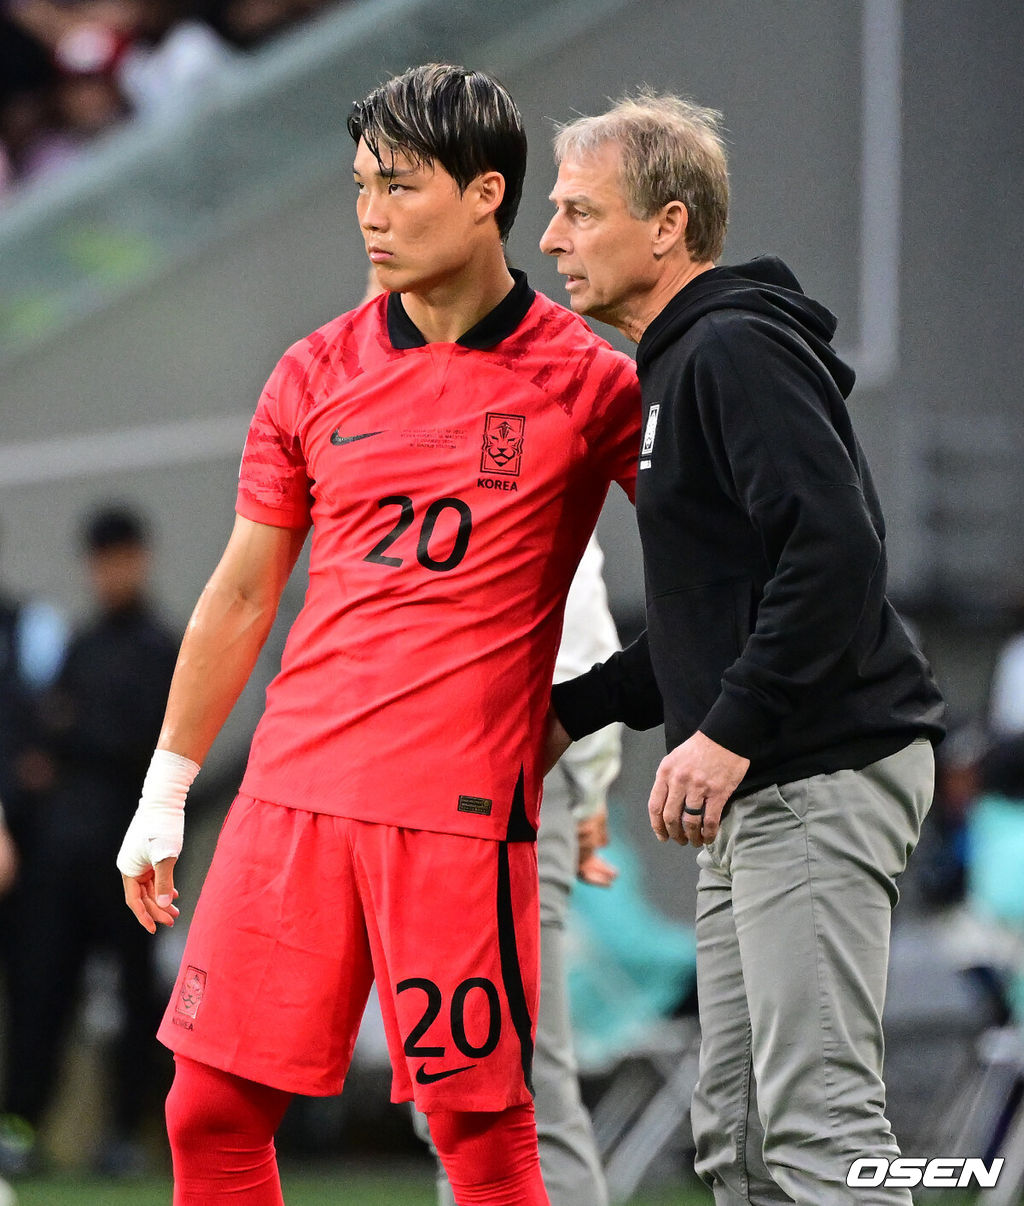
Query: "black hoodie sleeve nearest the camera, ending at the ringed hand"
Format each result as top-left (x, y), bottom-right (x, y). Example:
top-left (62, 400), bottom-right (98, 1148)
top-left (695, 315), bottom-right (884, 756)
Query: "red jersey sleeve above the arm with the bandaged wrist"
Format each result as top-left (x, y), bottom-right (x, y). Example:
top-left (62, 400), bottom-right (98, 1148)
top-left (235, 349), bottom-right (312, 528)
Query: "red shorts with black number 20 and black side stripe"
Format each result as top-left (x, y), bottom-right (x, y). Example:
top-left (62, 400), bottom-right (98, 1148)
top-left (159, 796), bottom-right (539, 1113)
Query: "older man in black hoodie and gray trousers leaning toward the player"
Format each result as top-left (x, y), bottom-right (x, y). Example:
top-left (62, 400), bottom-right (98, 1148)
top-left (540, 94), bottom-right (942, 1206)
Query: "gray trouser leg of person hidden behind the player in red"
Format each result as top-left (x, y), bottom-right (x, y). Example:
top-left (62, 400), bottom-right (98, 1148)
top-left (414, 766), bottom-right (608, 1206)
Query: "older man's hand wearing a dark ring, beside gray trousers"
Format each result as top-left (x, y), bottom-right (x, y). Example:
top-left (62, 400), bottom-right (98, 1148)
top-left (648, 732), bottom-right (750, 847)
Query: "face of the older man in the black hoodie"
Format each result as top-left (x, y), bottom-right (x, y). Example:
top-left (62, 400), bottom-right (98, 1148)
top-left (540, 142), bottom-right (657, 326)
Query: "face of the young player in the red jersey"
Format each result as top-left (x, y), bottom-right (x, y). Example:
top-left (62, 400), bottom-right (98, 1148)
top-left (352, 139), bottom-right (496, 292)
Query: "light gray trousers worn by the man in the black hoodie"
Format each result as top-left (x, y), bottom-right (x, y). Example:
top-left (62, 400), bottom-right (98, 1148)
top-left (692, 740), bottom-right (935, 1206)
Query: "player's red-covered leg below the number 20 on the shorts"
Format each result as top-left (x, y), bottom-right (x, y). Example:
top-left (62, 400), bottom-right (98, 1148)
top-left (427, 1103), bottom-right (549, 1206)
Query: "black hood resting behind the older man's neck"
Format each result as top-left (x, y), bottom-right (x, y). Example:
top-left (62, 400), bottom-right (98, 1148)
top-left (637, 256), bottom-right (856, 398)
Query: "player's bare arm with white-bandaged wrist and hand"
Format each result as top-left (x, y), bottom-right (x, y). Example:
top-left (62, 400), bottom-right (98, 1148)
top-left (117, 516), bottom-right (306, 933)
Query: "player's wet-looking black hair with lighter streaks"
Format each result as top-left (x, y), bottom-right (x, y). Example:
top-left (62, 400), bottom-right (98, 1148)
top-left (349, 63), bottom-right (526, 239)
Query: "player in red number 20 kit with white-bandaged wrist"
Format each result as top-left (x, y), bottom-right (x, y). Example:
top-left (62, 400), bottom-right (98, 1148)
top-left (118, 65), bottom-right (639, 1206)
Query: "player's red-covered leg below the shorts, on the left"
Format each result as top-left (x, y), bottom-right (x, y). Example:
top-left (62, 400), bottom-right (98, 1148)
top-left (166, 1055), bottom-right (292, 1206)
